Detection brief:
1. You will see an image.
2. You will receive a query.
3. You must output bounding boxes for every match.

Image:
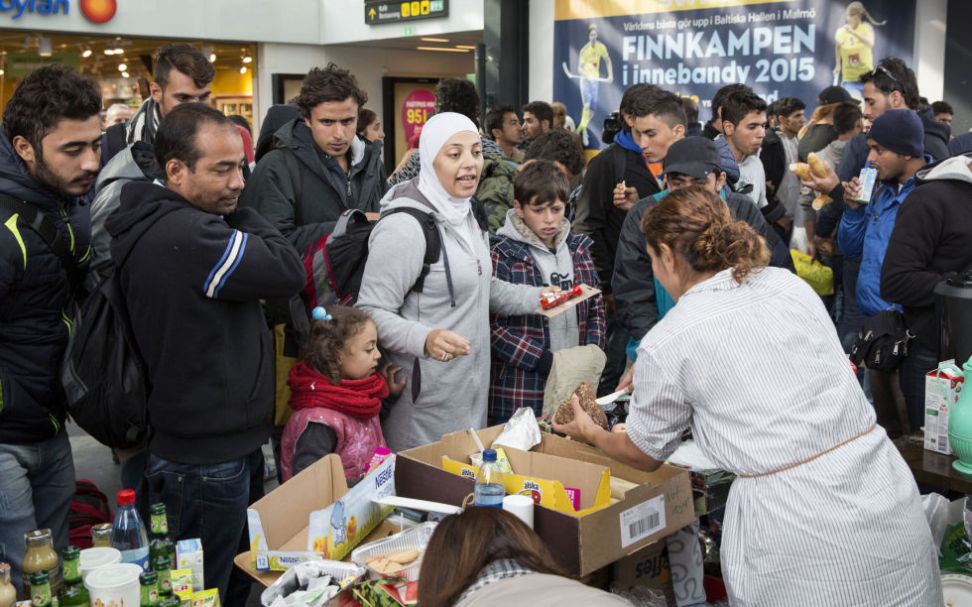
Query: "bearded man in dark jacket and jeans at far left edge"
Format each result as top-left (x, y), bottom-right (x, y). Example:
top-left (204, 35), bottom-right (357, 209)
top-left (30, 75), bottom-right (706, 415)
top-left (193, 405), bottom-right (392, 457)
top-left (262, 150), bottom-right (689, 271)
top-left (0, 65), bottom-right (101, 589)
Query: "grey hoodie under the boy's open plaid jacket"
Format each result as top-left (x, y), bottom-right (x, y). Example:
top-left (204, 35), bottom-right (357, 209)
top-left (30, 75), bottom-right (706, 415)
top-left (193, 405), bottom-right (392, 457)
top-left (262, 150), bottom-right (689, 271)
top-left (496, 209), bottom-right (580, 352)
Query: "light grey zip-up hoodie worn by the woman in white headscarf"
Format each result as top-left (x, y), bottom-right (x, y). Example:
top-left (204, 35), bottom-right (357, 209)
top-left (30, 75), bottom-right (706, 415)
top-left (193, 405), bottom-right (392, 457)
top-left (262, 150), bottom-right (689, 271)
top-left (356, 179), bottom-right (542, 451)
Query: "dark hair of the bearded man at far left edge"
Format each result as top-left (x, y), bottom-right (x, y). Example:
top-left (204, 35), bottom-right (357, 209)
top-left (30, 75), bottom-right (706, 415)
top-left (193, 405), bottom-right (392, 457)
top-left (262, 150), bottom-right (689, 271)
top-left (3, 64), bottom-right (101, 154)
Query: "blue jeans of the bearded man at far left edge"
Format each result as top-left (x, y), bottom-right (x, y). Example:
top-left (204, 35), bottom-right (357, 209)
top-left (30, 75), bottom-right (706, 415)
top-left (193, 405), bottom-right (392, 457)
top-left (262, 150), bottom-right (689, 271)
top-left (0, 430), bottom-right (74, 592)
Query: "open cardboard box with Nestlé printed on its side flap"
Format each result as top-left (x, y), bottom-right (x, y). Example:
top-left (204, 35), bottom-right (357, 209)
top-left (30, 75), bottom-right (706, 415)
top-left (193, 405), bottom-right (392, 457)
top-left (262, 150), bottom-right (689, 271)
top-left (234, 454), bottom-right (398, 585)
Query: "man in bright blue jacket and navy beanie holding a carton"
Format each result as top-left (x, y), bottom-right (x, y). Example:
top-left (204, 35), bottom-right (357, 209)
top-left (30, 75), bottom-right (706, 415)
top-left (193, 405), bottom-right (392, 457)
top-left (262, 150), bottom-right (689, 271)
top-left (837, 109), bottom-right (926, 434)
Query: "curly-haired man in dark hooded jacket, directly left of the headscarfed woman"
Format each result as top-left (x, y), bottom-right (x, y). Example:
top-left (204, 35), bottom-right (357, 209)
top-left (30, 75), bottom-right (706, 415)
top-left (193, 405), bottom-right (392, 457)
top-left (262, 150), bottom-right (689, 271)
top-left (240, 63), bottom-right (387, 255)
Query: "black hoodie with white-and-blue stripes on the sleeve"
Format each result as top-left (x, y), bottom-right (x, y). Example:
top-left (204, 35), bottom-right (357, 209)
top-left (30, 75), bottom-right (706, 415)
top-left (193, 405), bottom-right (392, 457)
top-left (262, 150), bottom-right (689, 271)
top-left (105, 181), bottom-right (305, 464)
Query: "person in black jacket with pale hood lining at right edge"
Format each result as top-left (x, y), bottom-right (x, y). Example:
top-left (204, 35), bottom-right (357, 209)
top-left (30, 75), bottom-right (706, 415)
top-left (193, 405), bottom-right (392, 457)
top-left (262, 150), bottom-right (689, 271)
top-left (881, 154), bottom-right (972, 425)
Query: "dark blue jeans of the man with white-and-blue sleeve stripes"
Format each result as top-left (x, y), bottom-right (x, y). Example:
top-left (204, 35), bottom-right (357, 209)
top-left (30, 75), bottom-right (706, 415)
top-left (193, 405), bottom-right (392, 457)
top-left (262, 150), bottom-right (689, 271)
top-left (145, 454), bottom-right (250, 602)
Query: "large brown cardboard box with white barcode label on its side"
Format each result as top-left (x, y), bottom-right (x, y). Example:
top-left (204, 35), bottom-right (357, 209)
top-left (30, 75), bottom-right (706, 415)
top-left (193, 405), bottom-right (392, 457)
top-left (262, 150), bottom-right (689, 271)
top-left (395, 426), bottom-right (695, 576)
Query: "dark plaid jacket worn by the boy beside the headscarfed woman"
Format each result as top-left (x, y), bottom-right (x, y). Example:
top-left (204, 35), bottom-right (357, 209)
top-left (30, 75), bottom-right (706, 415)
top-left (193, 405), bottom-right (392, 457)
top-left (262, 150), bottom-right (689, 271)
top-left (489, 232), bottom-right (606, 417)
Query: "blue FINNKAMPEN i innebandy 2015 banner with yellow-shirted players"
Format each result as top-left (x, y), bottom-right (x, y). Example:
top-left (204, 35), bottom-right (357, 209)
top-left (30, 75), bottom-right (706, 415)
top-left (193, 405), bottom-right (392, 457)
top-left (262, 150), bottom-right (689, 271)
top-left (553, 0), bottom-right (915, 147)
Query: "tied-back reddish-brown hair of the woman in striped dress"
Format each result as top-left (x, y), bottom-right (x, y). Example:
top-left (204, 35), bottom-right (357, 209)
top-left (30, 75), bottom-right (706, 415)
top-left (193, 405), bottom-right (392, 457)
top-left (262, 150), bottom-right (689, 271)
top-left (641, 186), bottom-right (769, 282)
